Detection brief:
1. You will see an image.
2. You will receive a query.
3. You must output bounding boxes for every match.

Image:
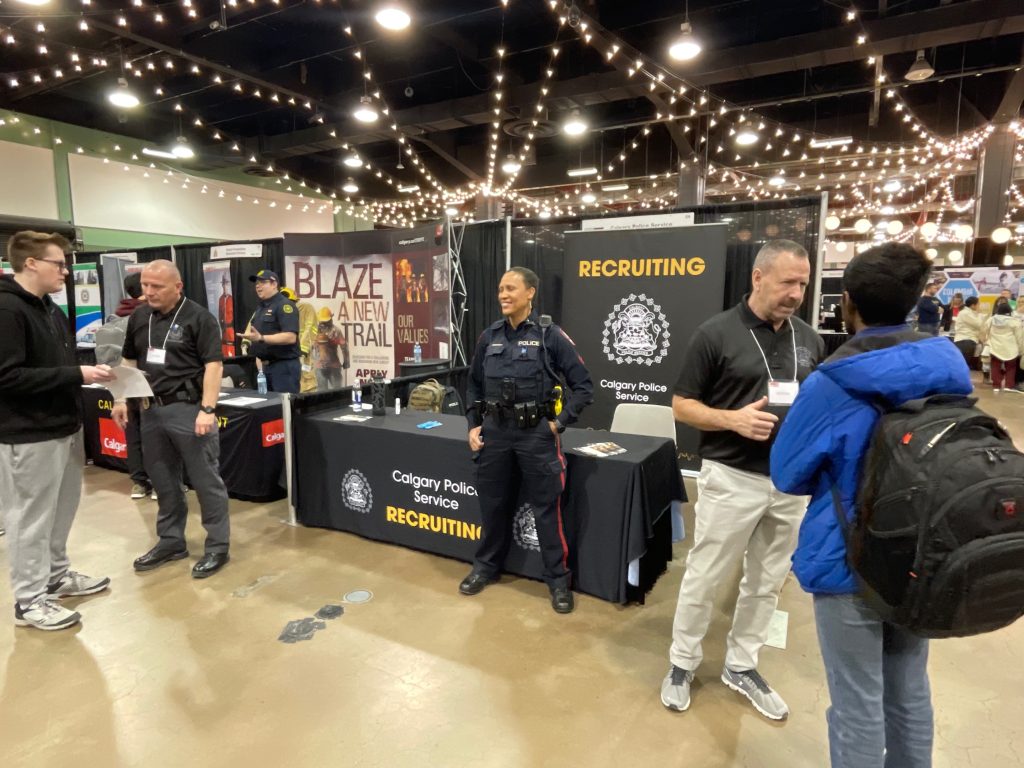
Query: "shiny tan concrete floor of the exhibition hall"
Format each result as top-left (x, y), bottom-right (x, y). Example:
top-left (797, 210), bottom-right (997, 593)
top-left (0, 376), bottom-right (1024, 768)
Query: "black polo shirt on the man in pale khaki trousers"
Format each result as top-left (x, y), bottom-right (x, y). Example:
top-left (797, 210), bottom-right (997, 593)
top-left (675, 295), bottom-right (825, 475)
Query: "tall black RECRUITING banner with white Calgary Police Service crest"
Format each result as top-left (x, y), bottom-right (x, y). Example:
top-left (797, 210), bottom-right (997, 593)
top-left (560, 224), bottom-right (726, 469)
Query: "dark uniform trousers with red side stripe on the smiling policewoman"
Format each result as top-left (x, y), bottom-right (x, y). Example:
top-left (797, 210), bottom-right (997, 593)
top-left (474, 414), bottom-right (570, 588)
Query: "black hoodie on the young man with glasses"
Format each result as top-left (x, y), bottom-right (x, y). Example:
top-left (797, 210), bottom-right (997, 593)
top-left (0, 274), bottom-right (82, 443)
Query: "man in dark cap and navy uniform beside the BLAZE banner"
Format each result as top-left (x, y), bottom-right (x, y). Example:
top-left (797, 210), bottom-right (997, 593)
top-left (243, 269), bottom-right (302, 393)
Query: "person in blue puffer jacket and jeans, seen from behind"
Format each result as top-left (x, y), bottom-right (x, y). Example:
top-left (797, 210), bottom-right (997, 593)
top-left (771, 244), bottom-right (972, 768)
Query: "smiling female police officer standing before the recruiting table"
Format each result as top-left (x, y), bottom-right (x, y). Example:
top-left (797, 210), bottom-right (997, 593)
top-left (459, 266), bottom-right (594, 613)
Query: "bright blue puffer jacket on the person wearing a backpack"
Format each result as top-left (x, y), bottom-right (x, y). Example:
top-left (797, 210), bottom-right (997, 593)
top-left (771, 327), bottom-right (973, 594)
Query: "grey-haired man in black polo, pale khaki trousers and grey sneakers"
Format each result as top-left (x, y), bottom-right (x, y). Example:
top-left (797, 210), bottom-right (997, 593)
top-left (662, 240), bottom-right (824, 720)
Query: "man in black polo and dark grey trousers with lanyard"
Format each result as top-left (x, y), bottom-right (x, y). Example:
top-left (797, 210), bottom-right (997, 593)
top-left (114, 259), bottom-right (230, 579)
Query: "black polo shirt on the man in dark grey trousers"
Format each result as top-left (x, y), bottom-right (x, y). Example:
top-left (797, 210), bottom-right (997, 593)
top-left (123, 296), bottom-right (224, 397)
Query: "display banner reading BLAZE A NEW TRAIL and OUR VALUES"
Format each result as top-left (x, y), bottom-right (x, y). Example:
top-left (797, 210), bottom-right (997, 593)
top-left (285, 223), bottom-right (452, 381)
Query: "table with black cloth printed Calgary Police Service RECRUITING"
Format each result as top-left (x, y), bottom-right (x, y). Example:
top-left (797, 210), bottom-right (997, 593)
top-left (292, 410), bottom-right (685, 603)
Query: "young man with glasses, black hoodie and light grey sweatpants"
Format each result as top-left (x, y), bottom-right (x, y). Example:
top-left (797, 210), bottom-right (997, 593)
top-left (0, 231), bottom-right (113, 631)
